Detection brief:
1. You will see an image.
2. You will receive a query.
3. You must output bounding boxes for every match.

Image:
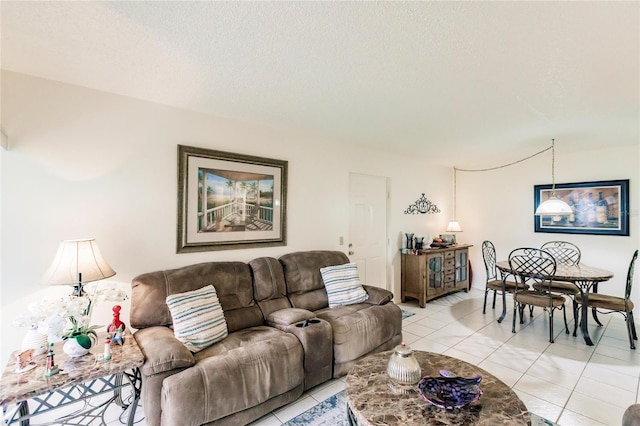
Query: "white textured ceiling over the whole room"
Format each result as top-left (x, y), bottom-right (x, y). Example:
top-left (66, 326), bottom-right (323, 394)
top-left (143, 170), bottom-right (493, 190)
top-left (1, 0), bottom-right (640, 167)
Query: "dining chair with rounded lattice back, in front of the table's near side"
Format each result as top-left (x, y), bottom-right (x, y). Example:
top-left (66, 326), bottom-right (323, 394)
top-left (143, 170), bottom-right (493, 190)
top-left (509, 247), bottom-right (569, 343)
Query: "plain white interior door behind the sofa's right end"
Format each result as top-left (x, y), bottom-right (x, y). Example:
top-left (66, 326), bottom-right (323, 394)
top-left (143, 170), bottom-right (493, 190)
top-left (349, 173), bottom-right (388, 289)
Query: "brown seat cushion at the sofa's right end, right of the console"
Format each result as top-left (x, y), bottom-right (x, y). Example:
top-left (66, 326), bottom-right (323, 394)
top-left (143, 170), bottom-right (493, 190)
top-left (315, 303), bottom-right (402, 364)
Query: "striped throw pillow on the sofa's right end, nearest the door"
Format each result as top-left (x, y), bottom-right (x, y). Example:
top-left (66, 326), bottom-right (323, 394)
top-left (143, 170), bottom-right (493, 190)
top-left (320, 263), bottom-right (369, 308)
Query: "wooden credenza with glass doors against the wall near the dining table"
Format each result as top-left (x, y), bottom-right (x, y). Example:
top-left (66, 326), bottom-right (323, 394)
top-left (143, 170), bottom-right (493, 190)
top-left (401, 244), bottom-right (472, 308)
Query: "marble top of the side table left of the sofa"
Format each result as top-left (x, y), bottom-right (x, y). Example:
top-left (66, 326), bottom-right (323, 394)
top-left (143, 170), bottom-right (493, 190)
top-left (0, 332), bottom-right (144, 407)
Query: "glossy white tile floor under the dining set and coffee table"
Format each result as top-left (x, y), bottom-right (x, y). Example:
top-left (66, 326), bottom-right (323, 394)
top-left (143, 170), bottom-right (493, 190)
top-left (32, 289), bottom-right (640, 426)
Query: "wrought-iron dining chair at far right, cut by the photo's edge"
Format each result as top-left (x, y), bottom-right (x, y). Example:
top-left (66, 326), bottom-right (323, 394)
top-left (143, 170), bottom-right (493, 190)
top-left (573, 250), bottom-right (638, 349)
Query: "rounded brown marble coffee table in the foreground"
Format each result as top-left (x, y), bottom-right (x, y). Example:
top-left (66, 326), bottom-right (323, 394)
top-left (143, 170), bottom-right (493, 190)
top-left (345, 351), bottom-right (531, 426)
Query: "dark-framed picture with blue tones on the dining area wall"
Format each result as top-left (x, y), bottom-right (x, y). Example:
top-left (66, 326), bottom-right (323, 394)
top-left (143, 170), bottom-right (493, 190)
top-left (533, 179), bottom-right (629, 236)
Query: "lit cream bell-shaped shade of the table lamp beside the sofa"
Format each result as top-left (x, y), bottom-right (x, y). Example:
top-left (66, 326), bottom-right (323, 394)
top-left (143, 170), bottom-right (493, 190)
top-left (42, 238), bottom-right (116, 296)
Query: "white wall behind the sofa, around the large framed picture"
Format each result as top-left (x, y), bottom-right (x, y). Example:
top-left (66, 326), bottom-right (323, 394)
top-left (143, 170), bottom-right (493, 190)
top-left (0, 72), bottom-right (451, 363)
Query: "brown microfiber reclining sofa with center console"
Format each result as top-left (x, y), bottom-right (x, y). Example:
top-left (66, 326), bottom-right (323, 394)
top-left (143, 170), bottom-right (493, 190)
top-left (130, 251), bottom-right (402, 426)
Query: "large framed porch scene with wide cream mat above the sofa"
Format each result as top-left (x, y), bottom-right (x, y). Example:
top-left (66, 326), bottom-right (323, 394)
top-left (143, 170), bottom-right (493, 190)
top-left (177, 145), bottom-right (288, 253)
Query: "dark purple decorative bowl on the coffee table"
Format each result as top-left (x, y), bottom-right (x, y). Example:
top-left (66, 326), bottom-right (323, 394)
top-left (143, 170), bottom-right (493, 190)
top-left (418, 370), bottom-right (482, 410)
